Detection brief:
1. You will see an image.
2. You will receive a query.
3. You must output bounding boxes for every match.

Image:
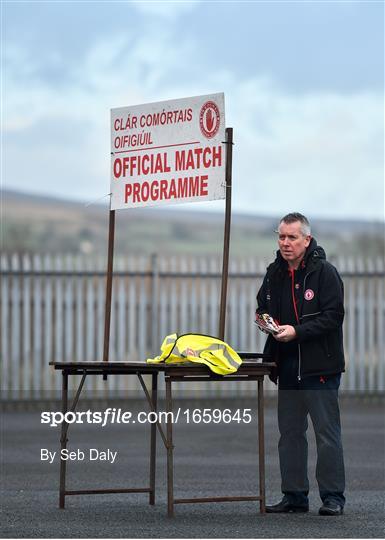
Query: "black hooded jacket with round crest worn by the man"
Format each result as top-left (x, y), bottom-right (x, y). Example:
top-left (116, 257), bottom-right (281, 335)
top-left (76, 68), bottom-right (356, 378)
top-left (257, 238), bottom-right (345, 380)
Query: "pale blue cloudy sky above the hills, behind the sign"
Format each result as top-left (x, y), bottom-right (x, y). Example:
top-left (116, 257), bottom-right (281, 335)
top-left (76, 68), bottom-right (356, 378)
top-left (1, 0), bottom-right (384, 220)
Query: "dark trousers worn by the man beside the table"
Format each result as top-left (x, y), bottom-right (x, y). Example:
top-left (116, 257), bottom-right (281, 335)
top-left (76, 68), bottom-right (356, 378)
top-left (278, 360), bottom-right (345, 506)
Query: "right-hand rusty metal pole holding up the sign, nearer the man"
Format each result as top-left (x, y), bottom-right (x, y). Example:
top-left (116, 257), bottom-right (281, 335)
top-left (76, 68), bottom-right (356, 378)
top-left (218, 128), bottom-right (233, 341)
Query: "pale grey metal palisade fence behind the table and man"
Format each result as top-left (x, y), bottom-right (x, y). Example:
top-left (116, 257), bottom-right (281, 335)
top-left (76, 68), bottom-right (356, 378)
top-left (0, 255), bottom-right (385, 399)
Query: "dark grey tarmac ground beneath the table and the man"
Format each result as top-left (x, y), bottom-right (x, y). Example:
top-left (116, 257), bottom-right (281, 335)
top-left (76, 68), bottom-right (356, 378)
top-left (0, 399), bottom-right (384, 538)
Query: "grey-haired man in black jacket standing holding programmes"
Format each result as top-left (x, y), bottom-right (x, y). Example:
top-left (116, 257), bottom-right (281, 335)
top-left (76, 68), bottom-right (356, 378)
top-left (257, 213), bottom-right (345, 516)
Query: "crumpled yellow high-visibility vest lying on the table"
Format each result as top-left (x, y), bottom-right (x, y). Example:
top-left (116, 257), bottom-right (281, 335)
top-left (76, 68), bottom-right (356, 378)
top-left (147, 334), bottom-right (242, 375)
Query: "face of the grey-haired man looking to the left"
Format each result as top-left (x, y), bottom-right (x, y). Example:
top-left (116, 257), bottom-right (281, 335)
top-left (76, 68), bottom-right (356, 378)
top-left (278, 221), bottom-right (311, 268)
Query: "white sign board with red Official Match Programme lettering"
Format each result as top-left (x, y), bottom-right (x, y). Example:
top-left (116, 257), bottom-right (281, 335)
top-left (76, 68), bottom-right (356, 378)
top-left (111, 94), bottom-right (226, 210)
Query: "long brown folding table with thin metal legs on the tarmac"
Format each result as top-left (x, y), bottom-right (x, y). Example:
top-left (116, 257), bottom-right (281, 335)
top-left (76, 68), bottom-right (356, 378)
top-left (50, 353), bottom-right (275, 517)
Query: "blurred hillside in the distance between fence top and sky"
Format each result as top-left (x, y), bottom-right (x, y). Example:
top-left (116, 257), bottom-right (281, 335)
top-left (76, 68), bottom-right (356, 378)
top-left (1, 190), bottom-right (384, 258)
